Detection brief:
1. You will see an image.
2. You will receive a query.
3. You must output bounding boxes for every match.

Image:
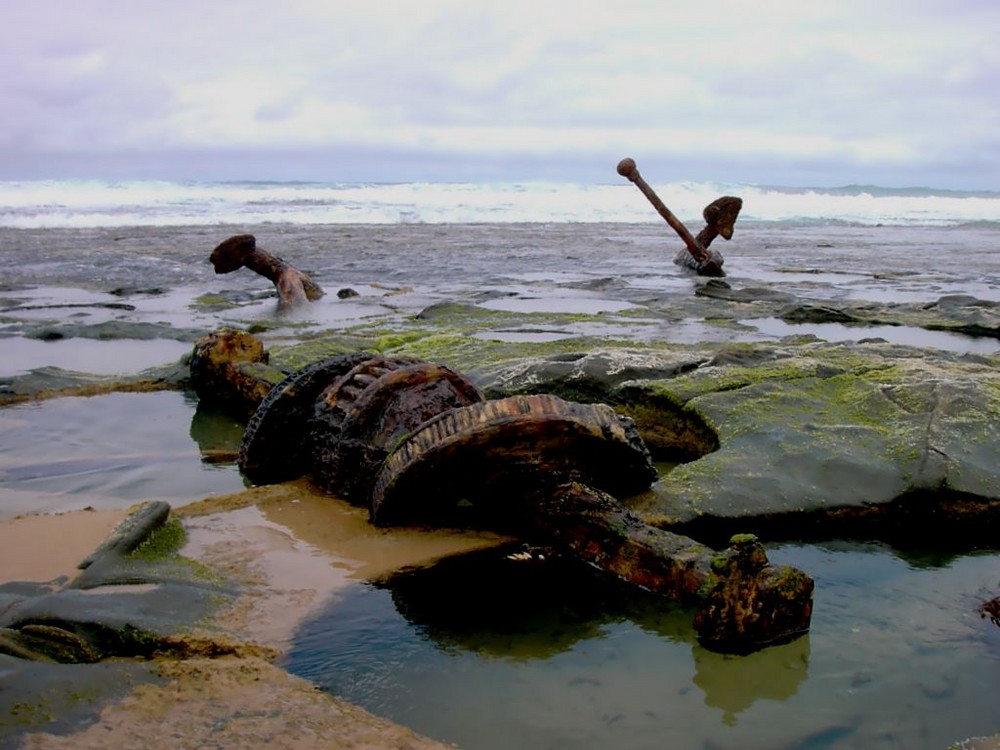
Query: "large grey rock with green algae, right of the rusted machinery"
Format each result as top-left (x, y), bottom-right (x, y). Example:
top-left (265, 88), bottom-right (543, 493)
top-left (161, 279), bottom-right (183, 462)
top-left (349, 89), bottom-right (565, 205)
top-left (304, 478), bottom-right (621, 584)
top-left (468, 341), bottom-right (1000, 545)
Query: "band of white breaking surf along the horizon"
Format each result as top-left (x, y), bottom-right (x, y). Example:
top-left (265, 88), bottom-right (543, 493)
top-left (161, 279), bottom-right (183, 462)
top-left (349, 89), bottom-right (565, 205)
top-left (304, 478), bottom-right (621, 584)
top-left (0, 180), bottom-right (1000, 228)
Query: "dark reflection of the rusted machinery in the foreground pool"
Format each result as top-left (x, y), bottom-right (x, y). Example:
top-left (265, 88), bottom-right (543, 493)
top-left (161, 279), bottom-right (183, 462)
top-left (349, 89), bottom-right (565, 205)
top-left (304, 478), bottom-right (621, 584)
top-left (379, 550), bottom-right (809, 724)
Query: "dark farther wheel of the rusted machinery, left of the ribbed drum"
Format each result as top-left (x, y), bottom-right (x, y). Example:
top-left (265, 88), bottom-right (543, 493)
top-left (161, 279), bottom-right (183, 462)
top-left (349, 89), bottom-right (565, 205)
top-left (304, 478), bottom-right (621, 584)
top-left (237, 352), bottom-right (375, 484)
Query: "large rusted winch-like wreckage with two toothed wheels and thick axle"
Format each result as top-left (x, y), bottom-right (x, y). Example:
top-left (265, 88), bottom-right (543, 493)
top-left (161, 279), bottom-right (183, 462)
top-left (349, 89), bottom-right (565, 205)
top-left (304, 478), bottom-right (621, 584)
top-left (196, 336), bottom-right (813, 653)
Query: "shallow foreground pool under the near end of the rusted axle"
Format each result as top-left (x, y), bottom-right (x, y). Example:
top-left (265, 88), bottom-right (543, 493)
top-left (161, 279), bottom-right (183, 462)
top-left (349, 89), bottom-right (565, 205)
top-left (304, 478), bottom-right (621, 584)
top-left (287, 543), bottom-right (1000, 750)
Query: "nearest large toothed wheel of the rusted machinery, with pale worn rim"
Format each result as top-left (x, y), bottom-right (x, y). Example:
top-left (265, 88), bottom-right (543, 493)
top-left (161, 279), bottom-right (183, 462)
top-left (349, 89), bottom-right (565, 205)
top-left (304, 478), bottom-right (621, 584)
top-left (370, 394), bottom-right (656, 527)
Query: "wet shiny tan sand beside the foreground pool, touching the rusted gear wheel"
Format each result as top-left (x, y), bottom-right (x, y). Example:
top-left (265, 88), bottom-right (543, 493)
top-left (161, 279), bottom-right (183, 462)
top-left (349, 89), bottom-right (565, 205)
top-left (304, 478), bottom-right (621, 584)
top-left (179, 482), bottom-right (504, 649)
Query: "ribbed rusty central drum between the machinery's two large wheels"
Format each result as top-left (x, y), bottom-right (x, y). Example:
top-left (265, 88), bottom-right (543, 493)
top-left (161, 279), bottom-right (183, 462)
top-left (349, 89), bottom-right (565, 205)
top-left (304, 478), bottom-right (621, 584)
top-left (310, 357), bottom-right (483, 505)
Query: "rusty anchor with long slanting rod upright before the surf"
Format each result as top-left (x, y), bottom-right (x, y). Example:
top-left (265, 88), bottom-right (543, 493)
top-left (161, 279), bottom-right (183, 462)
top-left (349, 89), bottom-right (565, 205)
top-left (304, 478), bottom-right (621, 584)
top-left (618, 158), bottom-right (743, 276)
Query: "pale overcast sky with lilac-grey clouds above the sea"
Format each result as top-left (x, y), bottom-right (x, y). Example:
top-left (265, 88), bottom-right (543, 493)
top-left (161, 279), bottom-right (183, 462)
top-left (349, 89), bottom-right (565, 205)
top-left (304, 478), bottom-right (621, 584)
top-left (0, 0), bottom-right (1000, 190)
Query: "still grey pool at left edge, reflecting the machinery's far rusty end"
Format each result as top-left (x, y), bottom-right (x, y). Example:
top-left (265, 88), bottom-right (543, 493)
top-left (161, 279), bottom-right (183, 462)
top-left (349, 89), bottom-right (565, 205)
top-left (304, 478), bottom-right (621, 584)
top-left (0, 391), bottom-right (245, 518)
